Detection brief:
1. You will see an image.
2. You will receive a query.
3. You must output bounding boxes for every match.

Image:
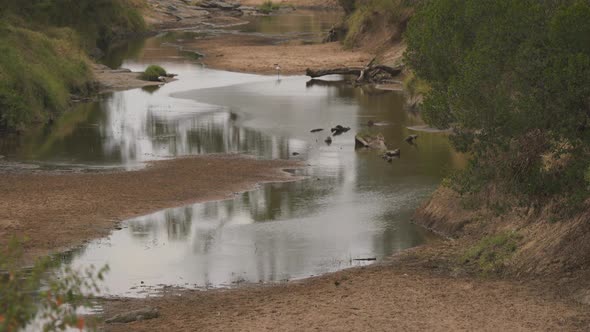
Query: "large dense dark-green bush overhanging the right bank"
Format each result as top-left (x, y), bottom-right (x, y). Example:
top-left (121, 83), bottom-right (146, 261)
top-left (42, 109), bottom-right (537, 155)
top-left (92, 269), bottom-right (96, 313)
top-left (405, 0), bottom-right (590, 206)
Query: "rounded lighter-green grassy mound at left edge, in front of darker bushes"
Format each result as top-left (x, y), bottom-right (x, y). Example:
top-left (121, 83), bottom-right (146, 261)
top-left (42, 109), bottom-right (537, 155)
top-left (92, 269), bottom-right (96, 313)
top-left (0, 26), bottom-right (92, 128)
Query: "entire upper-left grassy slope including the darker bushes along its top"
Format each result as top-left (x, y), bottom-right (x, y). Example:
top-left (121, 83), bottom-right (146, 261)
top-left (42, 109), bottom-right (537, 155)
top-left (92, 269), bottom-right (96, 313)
top-left (0, 0), bottom-right (145, 130)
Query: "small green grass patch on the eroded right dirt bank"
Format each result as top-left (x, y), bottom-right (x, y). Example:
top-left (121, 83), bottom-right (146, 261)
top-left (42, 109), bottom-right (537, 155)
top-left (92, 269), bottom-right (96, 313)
top-left (461, 232), bottom-right (521, 275)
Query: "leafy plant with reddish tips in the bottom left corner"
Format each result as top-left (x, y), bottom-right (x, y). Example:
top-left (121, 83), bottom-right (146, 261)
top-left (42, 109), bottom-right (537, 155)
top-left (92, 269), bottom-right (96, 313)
top-left (0, 239), bottom-right (108, 331)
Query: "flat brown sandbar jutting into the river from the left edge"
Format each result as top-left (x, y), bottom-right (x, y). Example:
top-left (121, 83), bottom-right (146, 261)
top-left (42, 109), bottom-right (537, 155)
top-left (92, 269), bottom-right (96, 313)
top-left (0, 155), bottom-right (299, 258)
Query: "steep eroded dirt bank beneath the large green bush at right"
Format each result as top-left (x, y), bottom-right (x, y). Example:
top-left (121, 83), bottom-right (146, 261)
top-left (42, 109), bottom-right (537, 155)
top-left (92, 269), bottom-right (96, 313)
top-left (415, 187), bottom-right (590, 304)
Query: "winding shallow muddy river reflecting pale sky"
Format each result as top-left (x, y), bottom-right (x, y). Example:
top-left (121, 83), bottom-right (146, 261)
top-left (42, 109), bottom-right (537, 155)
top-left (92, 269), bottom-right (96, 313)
top-left (0, 12), bottom-right (462, 296)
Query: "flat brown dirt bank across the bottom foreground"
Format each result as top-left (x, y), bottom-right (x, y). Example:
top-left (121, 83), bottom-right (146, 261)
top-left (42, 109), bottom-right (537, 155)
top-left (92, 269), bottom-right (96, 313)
top-left (104, 243), bottom-right (590, 331)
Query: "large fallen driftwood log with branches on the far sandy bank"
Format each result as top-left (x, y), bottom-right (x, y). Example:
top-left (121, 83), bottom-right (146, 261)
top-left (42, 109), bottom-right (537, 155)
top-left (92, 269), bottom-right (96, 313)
top-left (305, 58), bottom-right (402, 83)
